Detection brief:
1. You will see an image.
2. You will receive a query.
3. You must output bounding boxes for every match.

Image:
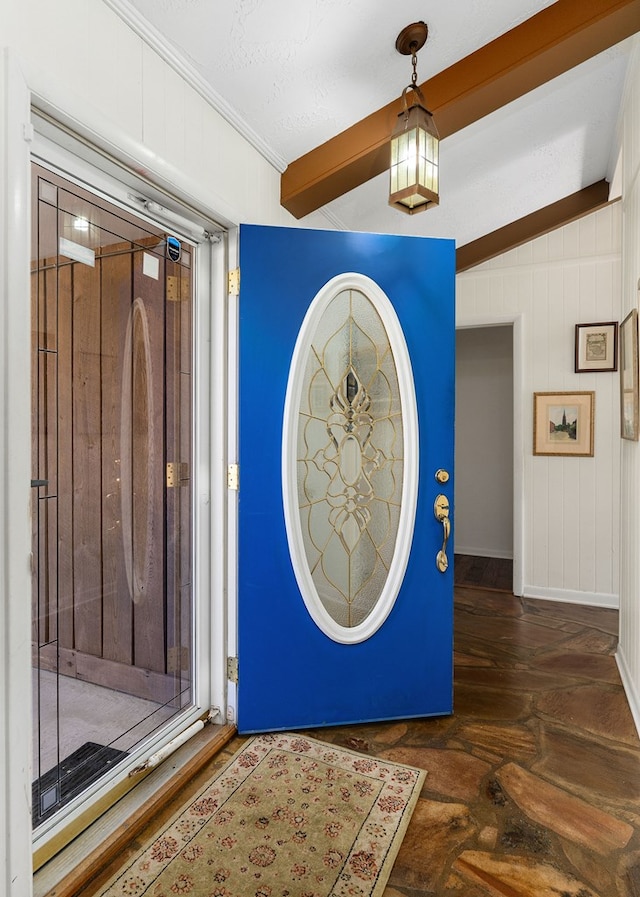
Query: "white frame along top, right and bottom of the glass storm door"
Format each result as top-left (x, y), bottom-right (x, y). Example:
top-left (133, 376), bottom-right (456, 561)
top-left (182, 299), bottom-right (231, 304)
top-left (32, 135), bottom-right (231, 857)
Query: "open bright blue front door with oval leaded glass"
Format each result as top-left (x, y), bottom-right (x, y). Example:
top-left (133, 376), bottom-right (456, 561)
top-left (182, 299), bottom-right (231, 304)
top-left (238, 220), bottom-right (455, 732)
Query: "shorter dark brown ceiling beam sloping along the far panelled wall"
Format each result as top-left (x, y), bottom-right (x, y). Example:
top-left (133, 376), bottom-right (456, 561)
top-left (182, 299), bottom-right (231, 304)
top-left (456, 180), bottom-right (609, 274)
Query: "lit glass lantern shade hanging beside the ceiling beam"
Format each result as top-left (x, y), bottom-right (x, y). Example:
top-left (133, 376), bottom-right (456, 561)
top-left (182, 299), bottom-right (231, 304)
top-left (389, 104), bottom-right (440, 215)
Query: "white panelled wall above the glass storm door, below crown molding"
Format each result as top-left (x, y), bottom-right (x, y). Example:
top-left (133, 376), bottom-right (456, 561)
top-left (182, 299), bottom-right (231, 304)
top-left (6, 0), bottom-right (293, 231)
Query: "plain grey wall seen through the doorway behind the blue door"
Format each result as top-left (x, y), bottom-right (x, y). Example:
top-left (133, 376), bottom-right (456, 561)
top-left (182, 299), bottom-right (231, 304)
top-left (454, 326), bottom-right (513, 558)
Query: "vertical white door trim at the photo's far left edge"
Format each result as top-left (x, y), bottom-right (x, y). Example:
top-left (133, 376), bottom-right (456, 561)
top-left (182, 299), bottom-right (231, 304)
top-left (0, 43), bottom-right (32, 897)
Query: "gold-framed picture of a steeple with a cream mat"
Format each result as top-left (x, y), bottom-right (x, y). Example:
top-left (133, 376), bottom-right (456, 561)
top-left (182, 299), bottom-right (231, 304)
top-left (533, 392), bottom-right (595, 458)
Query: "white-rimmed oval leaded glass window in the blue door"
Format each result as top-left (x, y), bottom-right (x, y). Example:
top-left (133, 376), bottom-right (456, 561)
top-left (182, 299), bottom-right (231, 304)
top-left (282, 274), bottom-right (418, 643)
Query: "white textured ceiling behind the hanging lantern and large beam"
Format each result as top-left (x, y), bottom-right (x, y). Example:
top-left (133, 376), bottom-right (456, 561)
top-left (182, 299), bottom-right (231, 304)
top-left (125, 0), bottom-right (629, 245)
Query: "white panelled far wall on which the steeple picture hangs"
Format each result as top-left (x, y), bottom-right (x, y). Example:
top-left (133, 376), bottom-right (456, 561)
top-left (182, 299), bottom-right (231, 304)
top-left (457, 203), bottom-right (622, 606)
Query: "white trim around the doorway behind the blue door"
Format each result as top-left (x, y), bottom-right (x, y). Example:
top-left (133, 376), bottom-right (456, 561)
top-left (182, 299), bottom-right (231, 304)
top-left (456, 314), bottom-right (526, 596)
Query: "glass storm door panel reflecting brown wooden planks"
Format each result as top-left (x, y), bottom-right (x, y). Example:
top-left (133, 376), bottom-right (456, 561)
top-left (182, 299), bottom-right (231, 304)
top-left (31, 166), bottom-right (192, 828)
